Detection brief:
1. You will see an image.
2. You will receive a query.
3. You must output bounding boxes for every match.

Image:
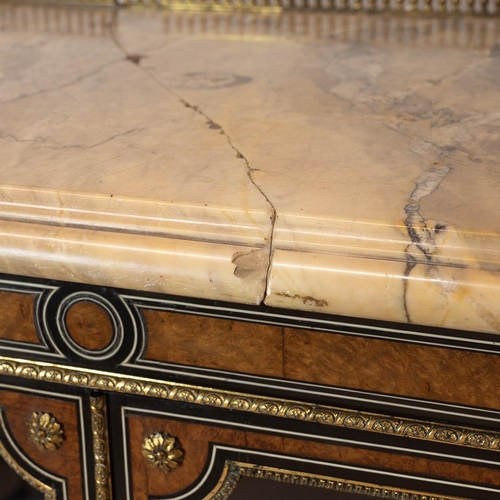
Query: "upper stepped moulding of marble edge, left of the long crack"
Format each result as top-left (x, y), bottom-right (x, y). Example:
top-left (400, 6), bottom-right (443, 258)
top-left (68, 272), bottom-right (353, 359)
top-left (0, 185), bottom-right (272, 247)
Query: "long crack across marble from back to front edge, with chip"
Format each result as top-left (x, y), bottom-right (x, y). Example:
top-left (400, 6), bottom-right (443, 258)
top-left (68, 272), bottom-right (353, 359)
top-left (108, 10), bottom-right (277, 304)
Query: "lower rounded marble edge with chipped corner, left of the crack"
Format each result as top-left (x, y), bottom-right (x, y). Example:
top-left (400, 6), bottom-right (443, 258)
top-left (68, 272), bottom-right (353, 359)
top-left (0, 220), bottom-right (269, 304)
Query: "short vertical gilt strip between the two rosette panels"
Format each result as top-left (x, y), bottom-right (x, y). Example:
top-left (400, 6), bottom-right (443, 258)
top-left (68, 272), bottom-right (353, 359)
top-left (90, 396), bottom-right (113, 500)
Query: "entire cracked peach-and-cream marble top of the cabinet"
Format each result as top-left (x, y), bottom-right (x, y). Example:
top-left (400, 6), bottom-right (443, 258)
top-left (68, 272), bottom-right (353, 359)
top-left (0, 6), bottom-right (500, 333)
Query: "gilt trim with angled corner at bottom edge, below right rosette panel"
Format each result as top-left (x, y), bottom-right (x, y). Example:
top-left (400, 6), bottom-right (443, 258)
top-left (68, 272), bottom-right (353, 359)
top-left (204, 460), bottom-right (463, 500)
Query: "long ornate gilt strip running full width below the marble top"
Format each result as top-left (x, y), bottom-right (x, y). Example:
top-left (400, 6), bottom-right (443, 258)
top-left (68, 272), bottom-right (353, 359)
top-left (0, 356), bottom-right (500, 452)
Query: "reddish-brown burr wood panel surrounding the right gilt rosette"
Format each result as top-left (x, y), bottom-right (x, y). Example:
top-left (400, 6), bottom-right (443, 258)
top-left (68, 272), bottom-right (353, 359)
top-left (127, 414), bottom-right (500, 500)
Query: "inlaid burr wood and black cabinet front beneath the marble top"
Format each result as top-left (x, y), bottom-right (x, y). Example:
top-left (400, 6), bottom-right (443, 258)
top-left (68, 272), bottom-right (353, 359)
top-left (0, 275), bottom-right (500, 500)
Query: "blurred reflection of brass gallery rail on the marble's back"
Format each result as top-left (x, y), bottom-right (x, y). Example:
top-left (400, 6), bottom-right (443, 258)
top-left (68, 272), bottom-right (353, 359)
top-left (0, 5), bottom-right (500, 49)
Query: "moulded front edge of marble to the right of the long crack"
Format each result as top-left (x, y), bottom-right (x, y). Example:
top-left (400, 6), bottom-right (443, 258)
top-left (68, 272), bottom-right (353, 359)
top-left (264, 213), bottom-right (500, 333)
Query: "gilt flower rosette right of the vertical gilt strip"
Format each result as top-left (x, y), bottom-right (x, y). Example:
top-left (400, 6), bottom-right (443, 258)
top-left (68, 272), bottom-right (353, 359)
top-left (142, 432), bottom-right (184, 474)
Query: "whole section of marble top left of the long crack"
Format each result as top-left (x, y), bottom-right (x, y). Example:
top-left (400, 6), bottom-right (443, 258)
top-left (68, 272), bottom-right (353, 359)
top-left (0, 7), bottom-right (274, 303)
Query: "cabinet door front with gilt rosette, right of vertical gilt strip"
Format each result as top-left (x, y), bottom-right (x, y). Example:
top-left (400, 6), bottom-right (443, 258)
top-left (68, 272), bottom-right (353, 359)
top-left (112, 401), bottom-right (500, 500)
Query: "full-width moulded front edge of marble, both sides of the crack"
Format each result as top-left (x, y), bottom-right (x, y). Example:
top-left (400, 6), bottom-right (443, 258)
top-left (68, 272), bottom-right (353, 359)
top-left (0, 193), bottom-right (500, 333)
